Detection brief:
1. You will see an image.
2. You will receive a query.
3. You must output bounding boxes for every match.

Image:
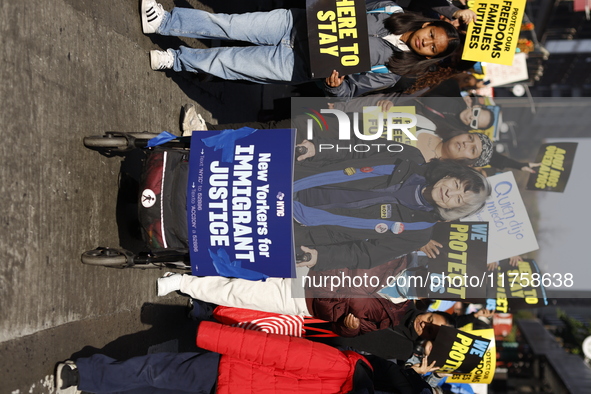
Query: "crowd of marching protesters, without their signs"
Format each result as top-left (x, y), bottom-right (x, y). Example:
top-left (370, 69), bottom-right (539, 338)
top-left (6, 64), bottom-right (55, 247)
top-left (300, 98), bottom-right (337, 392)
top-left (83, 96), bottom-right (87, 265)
top-left (56, 0), bottom-right (536, 393)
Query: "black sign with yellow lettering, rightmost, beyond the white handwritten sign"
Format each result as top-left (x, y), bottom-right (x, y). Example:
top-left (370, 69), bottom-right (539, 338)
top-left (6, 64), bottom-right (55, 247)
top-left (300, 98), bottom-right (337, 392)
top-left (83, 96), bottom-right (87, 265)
top-left (527, 142), bottom-right (578, 193)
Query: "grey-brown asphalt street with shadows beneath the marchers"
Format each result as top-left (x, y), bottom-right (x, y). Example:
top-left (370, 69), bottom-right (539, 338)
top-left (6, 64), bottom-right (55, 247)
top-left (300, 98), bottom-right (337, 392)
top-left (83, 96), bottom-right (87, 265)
top-left (0, 0), bottom-right (291, 394)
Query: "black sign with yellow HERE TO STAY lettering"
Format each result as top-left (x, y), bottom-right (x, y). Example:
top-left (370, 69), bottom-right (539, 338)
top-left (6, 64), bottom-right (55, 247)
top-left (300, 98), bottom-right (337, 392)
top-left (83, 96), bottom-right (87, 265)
top-left (306, 0), bottom-right (371, 78)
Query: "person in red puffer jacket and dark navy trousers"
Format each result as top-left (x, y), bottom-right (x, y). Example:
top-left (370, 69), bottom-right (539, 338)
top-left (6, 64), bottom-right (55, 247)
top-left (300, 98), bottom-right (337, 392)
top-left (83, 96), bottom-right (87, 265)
top-left (55, 322), bottom-right (374, 394)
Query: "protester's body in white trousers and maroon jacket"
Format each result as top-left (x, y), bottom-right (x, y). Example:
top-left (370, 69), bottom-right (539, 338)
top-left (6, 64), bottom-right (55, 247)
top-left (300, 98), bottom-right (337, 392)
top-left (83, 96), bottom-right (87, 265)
top-left (158, 257), bottom-right (412, 336)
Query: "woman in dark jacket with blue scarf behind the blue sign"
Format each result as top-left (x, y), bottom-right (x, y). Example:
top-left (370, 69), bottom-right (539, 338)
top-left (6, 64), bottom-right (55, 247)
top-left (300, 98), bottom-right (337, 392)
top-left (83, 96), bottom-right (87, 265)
top-left (294, 152), bottom-right (490, 270)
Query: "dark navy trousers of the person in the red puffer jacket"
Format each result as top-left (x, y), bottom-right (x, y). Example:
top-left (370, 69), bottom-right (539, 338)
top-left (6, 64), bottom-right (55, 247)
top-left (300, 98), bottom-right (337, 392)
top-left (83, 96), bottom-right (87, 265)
top-left (76, 353), bottom-right (220, 394)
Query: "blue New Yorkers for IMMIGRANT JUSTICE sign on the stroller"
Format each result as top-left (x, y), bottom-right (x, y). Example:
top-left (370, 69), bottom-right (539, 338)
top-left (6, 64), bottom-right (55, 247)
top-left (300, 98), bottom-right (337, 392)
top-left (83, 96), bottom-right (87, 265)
top-left (187, 127), bottom-right (295, 279)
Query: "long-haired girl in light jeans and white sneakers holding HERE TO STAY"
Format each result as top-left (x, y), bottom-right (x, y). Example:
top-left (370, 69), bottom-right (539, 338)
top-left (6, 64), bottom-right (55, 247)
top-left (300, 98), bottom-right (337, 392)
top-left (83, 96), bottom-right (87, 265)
top-left (141, 0), bottom-right (464, 97)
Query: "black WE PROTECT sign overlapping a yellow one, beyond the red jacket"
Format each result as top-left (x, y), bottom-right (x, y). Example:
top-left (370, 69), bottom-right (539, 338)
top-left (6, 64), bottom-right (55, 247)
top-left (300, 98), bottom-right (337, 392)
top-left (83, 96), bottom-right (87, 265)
top-left (428, 326), bottom-right (494, 373)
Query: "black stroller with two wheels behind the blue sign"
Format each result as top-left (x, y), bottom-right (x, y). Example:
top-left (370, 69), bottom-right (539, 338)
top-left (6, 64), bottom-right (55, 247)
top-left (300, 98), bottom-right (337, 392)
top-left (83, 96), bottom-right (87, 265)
top-left (81, 132), bottom-right (191, 271)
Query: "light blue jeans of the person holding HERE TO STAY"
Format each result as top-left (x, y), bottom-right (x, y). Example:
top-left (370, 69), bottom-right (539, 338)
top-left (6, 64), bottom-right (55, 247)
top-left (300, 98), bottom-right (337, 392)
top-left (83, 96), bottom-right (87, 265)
top-left (158, 8), bottom-right (304, 83)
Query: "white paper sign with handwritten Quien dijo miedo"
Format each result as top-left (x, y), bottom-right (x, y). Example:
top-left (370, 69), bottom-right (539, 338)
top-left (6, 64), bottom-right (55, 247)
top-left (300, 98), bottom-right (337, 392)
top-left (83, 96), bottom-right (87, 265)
top-left (462, 171), bottom-right (539, 263)
